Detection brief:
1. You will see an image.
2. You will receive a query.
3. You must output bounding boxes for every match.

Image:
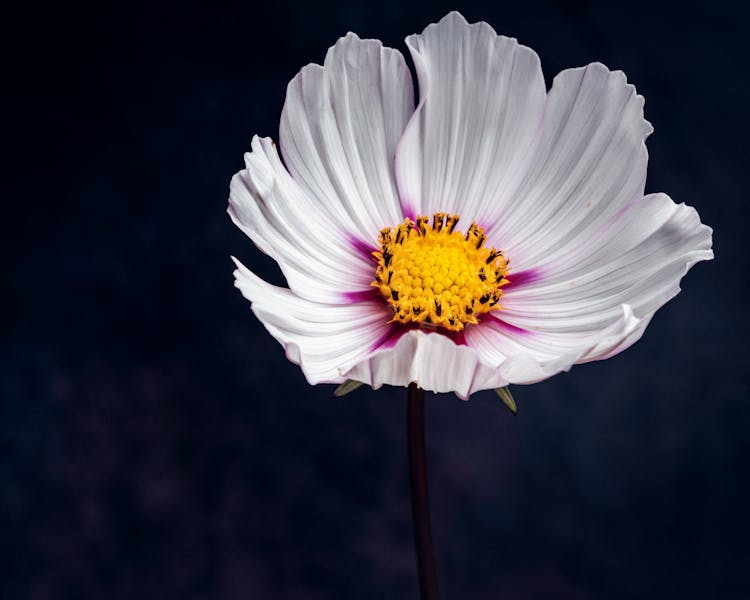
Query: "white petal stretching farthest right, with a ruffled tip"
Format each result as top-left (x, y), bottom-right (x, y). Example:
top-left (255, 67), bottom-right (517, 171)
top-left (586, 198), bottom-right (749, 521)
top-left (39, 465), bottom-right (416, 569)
top-left (501, 194), bottom-right (713, 362)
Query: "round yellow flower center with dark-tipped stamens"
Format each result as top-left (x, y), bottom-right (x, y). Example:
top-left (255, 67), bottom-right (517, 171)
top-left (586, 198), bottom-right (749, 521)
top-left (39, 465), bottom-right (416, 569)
top-left (372, 213), bottom-right (510, 331)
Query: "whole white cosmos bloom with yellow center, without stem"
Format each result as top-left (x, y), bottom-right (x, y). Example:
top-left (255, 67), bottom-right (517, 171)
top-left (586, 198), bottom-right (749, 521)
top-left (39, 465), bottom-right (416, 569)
top-left (229, 12), bottom-right (713, 398)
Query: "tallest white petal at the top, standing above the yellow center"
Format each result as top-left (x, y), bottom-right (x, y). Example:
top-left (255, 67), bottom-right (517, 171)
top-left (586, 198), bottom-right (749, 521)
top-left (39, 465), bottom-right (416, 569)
top-left (396, 12), bottom-right (546, 224)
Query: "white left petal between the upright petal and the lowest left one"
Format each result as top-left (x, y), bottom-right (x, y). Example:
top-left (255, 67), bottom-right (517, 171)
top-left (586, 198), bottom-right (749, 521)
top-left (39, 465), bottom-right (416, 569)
top-left (229, 137), bottom-right (373, 303)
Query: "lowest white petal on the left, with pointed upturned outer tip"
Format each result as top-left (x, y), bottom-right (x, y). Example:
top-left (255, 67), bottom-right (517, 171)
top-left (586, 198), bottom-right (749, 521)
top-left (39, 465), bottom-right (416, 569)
top-left (233, 259), bottom-right (391, 385)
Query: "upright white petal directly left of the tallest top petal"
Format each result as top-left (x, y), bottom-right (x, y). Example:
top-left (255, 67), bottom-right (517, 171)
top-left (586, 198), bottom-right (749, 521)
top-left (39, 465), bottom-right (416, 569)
top-left (280, 33), bottom-right (414, 243)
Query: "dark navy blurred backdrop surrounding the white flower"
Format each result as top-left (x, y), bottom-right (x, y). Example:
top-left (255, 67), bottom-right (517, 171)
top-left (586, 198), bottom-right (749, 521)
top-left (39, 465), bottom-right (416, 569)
top-left (5, 0), bottom-right (750, 600)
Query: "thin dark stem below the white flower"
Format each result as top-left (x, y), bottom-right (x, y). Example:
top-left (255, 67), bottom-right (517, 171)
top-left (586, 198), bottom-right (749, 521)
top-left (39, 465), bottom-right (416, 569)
top-left (406, 382), bottom-right (440, 600)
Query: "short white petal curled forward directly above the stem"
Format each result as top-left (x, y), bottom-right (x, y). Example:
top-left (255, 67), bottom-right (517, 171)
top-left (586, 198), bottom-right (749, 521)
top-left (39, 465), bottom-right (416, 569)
top-left (344, 329), bottom-right (508, 399)
